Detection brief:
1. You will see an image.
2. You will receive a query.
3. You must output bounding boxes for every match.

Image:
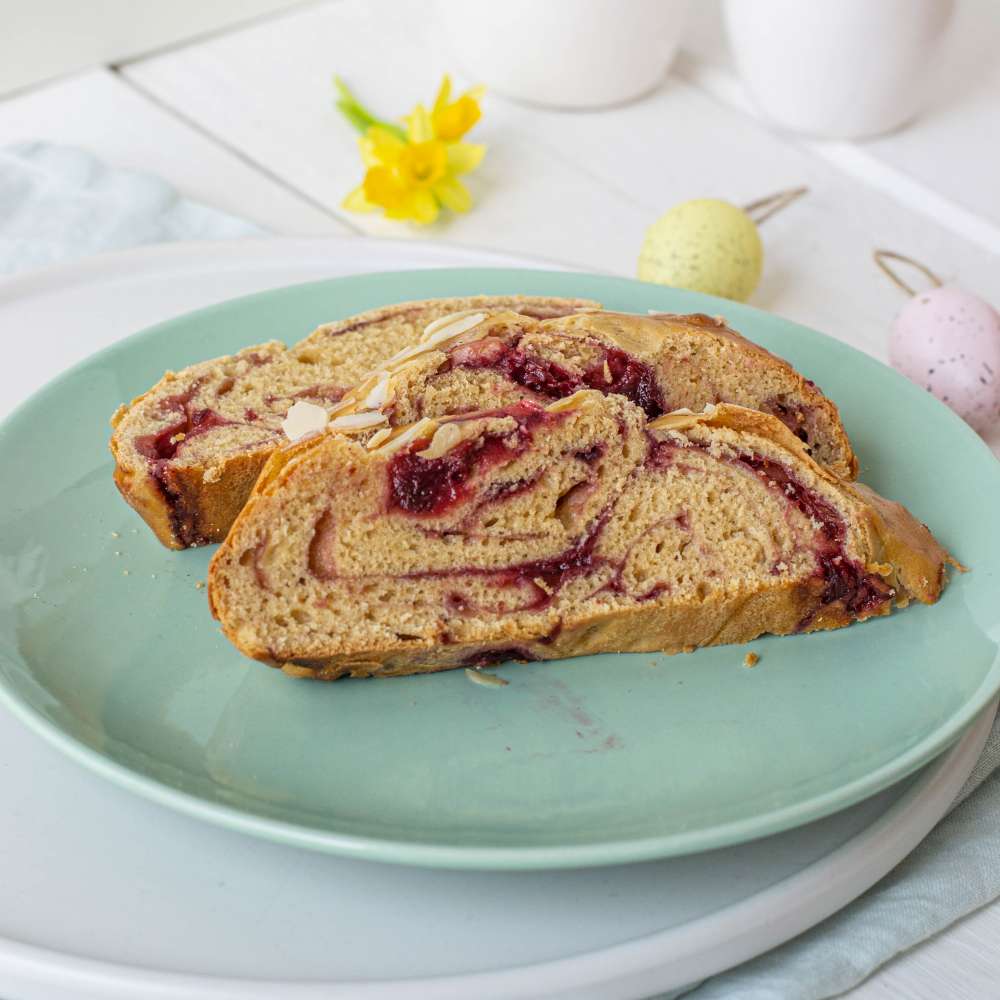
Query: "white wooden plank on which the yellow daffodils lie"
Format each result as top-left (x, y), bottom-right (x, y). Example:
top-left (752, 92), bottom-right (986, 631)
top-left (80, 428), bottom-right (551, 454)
top-left (123, 0), bottom-right (647, 271)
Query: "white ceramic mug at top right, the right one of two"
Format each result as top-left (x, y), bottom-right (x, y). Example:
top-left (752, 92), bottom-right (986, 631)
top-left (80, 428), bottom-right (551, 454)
top-left (725, 0), bottom-right (954, 139)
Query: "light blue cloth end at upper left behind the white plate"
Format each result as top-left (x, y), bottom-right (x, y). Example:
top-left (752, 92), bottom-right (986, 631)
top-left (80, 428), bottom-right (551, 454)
top-left (0, 142), bottom-right (261, 274)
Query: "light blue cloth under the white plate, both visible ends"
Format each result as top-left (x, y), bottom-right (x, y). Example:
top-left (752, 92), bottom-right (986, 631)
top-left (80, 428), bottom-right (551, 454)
top-left (0, 143), bottom-right (1000, 1000)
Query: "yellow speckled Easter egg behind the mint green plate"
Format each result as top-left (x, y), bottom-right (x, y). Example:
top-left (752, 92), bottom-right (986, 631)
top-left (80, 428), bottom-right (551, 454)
top-left (639, 198), bottom-right (764, 302)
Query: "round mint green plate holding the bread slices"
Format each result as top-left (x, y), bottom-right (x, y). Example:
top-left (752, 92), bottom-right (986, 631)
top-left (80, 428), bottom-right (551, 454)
top-left (0, 270), bottom-right (1000, 869)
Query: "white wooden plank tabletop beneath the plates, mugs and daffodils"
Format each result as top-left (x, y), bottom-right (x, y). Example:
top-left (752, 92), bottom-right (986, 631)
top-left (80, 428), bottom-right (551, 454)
top-left (0, 0), bottom-right (1000, 1000)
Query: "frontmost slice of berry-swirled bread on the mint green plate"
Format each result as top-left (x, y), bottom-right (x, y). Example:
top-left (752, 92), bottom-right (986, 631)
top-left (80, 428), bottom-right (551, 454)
top-left (209, 390), bottom-right (948, 679)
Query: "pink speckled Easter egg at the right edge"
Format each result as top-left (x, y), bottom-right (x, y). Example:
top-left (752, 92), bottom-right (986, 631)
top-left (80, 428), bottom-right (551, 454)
top-left (889, 285), bottom-right (1000, 432)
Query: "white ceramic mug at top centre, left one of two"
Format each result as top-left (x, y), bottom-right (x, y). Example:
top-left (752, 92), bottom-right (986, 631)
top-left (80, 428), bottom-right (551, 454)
top-left (438, 0), bottom-right (689, 108)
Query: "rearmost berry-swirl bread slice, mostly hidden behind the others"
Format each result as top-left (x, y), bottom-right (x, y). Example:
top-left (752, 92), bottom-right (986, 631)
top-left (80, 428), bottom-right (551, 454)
top-left (111, 295), bottom-right (600, 549)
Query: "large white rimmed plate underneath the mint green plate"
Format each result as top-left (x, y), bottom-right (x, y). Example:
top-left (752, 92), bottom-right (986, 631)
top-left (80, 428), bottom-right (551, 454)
top-left (0, 239), bottom-right (992, 1000)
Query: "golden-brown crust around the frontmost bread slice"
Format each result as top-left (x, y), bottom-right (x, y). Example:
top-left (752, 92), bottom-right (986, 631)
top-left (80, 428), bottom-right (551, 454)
top-left (209, 404), bottom-right (944, 680)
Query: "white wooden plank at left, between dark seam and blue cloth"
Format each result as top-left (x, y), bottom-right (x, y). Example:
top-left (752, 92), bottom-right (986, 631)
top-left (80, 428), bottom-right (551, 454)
top-left (0, 69), bottom-right (351, 236)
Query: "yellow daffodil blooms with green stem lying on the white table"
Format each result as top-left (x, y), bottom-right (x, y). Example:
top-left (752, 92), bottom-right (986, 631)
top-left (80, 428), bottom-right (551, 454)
top-left (338, 77), bottom-right (486, 225)
